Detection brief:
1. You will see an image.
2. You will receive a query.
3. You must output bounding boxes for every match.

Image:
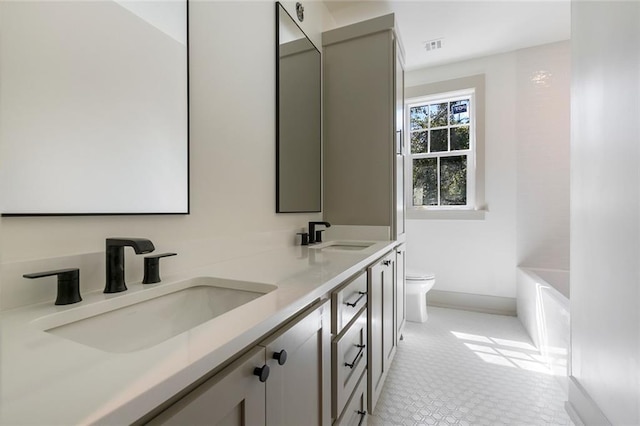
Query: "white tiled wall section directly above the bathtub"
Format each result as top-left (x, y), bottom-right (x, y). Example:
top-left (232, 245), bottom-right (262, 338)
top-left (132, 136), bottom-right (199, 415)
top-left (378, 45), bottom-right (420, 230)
top-left (516, 42), bottom-right (571, 270)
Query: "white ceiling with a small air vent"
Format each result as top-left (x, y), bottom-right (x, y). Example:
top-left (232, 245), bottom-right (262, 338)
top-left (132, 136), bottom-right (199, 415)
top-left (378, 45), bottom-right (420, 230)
top-left (324, 0), bottom-right (571, 70)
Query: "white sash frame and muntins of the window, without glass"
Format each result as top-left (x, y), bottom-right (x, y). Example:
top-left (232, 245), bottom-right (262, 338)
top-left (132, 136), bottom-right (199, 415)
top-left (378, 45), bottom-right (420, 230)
top-left (405, 88), bottom-right (476, 210)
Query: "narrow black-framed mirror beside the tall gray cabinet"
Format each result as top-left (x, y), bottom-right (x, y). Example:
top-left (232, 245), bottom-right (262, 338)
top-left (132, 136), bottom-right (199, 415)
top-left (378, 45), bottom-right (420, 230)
top-left (276, 3), bottom-right (322, 213)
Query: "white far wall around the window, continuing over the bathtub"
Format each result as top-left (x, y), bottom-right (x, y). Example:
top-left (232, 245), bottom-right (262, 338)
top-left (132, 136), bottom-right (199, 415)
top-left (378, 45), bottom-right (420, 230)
top-left (406, 42), bottom-right (569, 298)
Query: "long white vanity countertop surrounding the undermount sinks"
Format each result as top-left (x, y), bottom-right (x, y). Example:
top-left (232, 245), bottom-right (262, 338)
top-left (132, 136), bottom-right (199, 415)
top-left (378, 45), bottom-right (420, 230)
top-left (0, 241), bottom-right (398, 425)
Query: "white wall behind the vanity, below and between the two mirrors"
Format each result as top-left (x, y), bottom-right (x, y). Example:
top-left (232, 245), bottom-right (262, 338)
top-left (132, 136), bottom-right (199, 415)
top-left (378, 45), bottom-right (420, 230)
top-left (0, 1), bottom-right (331, 310)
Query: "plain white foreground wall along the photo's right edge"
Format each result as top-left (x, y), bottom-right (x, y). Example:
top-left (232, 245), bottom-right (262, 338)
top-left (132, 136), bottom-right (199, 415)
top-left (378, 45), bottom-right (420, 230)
top-left (569, 1), bottom-right (640, 425)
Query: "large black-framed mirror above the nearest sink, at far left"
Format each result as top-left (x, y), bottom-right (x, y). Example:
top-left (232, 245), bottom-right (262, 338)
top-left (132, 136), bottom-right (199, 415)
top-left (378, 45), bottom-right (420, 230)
top-left (0, 0), bottom-right (189, 216)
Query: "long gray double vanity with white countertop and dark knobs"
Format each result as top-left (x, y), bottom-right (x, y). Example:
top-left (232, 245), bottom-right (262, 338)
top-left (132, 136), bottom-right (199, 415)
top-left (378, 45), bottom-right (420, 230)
top-left (0, 241), bottom-right (404, 425)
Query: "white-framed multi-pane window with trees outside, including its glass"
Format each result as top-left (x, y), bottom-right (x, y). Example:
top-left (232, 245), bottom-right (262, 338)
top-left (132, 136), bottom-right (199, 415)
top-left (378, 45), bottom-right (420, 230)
top-left (407, 89), bottom-right (476, 210)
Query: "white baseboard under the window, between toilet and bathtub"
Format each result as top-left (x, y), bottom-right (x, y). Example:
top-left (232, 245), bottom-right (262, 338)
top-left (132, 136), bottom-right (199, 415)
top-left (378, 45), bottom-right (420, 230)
top-left (427, 290), bottom-right (517, 316)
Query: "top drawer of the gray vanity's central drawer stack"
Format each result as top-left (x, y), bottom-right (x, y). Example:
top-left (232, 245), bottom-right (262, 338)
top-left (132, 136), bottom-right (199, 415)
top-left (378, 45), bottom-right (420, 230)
top-left (331, 271), bottom-right (367, 335)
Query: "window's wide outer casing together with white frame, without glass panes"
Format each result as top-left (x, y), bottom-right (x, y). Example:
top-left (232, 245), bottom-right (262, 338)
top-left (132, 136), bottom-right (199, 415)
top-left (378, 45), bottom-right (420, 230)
top-left (404, 74), bottom-right (489, 220)
